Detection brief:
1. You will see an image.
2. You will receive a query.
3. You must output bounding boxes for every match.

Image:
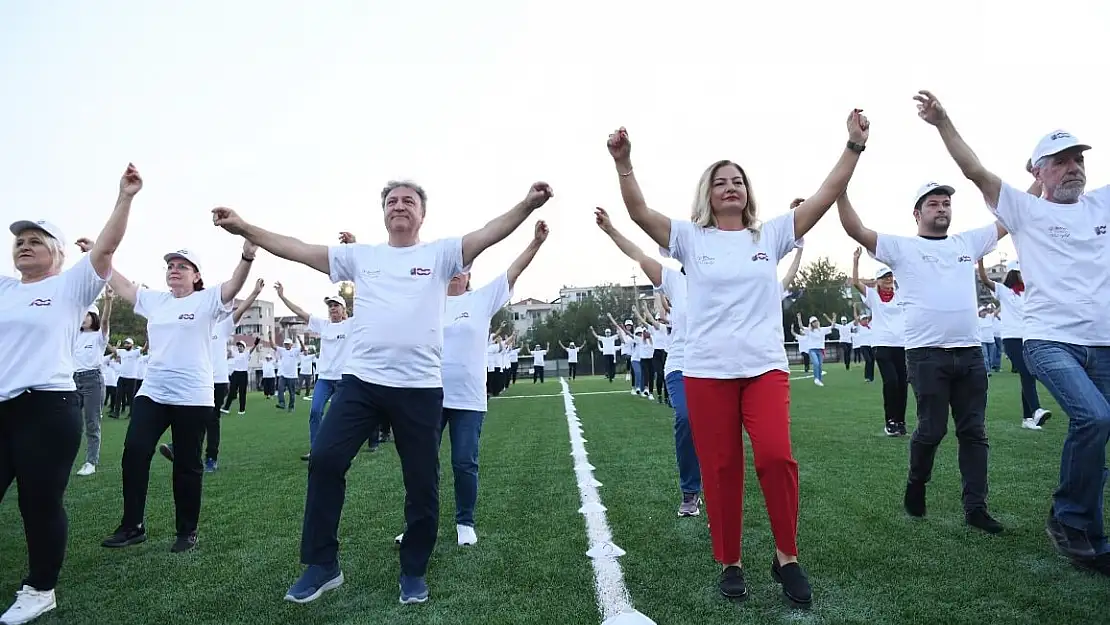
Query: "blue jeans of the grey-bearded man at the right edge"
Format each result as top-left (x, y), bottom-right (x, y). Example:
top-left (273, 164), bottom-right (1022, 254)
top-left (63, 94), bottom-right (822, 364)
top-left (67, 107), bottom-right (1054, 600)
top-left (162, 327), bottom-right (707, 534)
top-left (1026, 340), bottom-right (1110, 554)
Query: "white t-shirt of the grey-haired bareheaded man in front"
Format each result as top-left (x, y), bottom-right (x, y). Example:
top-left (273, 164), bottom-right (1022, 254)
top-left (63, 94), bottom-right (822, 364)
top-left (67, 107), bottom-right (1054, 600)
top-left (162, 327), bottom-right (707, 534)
top-left (327, 239), bottom-right (466, 389)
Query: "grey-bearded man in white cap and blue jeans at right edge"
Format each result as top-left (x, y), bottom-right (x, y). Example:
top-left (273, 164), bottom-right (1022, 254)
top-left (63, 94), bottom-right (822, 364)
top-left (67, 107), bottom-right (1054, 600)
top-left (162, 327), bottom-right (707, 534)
top-left (918, 92), bottom-right (1110, 576)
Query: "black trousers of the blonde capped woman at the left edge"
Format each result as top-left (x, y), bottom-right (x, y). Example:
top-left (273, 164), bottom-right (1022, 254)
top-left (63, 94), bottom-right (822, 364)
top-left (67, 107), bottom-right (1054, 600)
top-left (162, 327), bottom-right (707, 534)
top-left (0, 391), bottom-right (82, 591)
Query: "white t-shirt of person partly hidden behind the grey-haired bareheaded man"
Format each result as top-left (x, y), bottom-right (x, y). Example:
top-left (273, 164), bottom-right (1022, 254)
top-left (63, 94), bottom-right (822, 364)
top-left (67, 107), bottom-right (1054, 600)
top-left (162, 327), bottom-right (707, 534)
top-left (443, 274), bottom-right (512, 412)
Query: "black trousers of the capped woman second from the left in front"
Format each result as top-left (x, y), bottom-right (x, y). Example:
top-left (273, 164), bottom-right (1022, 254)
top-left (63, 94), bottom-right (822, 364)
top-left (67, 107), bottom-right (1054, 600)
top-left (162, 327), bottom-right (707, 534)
top-left (120, 396), bottom-right (213, 536)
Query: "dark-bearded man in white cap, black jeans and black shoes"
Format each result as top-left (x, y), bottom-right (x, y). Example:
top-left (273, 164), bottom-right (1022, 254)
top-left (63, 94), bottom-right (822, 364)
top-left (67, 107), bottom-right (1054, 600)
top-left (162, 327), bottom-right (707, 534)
top-left (837, 182), bottom-right (1007, 534)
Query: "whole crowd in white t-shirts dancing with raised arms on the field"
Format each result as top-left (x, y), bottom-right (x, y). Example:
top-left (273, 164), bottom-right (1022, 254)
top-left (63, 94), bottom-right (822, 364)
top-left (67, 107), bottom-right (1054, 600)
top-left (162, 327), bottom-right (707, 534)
top-left (0, 91), bottom-right (1110, 624)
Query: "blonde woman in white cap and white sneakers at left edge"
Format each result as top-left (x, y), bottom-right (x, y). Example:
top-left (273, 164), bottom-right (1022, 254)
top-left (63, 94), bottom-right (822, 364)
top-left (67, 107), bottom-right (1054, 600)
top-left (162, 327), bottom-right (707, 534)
top-left (0, 164), bottom-right (142, 624)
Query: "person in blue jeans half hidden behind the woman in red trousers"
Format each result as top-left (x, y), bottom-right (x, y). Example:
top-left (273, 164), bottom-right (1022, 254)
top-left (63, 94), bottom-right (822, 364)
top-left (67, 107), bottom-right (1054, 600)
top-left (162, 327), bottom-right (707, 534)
top-left (594, 208), bottom-right (702, 517)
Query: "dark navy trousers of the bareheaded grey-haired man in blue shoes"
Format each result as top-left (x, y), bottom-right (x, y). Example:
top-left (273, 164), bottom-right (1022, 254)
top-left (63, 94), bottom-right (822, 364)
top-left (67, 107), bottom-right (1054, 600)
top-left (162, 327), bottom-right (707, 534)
top-left (301, 375), bottom-right (443, 576)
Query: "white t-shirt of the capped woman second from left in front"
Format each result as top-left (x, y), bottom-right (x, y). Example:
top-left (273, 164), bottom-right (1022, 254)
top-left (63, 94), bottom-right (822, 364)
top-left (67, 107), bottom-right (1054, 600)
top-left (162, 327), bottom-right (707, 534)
top-left (135, 284), bottom-right (231, 406)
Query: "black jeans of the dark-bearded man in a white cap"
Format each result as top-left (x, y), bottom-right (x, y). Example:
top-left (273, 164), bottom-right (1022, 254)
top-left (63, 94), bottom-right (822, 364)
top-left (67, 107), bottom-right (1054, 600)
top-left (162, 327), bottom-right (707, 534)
top-left (906, 346), bottom-right (990, 513)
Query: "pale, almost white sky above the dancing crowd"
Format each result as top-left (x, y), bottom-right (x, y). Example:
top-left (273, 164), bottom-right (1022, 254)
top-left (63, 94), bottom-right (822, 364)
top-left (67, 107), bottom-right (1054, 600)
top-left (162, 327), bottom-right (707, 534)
top-left (0, 0), bottom-right (1110, 314)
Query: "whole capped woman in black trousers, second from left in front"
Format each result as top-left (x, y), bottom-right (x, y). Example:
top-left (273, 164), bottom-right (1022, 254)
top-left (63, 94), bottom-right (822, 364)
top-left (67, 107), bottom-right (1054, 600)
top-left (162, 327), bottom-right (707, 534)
top-left (101, 241), bottom-right (258, 553)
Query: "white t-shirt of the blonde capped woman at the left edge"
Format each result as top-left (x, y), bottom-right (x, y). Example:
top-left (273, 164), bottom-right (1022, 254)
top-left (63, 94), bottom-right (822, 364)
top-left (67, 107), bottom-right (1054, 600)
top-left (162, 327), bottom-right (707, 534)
top-left (0, 255), bottom-right (105, 399)
